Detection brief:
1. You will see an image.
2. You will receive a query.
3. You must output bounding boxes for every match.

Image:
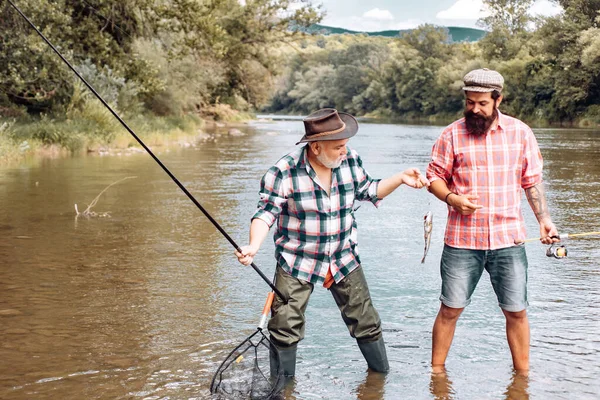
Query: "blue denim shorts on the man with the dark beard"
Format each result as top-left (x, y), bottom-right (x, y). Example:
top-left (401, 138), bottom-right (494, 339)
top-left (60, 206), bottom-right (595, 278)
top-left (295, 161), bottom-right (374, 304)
top-left (440, 244), bottom-right (529, 312)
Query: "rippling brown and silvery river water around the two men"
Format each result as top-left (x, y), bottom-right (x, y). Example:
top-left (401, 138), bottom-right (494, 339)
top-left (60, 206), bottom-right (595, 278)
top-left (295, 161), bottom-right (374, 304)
top-left (0, 120), bottom-right (600, 400)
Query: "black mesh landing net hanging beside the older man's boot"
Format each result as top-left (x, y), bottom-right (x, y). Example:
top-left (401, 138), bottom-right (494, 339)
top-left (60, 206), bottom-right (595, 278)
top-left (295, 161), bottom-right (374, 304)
top-left (210, 329), bottom-right (284, 399)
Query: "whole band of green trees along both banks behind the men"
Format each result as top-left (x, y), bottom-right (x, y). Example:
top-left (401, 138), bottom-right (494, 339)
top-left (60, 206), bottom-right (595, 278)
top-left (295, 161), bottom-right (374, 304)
top-left (0, 0), bottom-right (600, 124)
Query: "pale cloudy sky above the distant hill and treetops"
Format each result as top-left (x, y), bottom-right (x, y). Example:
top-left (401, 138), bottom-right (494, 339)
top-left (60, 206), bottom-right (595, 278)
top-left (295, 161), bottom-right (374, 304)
top-left (311, 0), bottom-right (562, 32)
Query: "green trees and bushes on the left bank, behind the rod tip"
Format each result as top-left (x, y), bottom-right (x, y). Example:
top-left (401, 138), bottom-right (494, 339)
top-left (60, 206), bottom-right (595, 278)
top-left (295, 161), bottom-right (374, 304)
top-left (0, 0), bottom-right (320, 115)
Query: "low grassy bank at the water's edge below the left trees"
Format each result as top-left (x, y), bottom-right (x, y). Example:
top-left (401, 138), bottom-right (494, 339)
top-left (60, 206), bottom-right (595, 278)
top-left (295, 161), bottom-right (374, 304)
top-left (0, 114), bottom-right (253, 166)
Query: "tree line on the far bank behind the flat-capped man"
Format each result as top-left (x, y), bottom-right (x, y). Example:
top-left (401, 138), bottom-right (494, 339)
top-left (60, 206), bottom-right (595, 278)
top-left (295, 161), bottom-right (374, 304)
top-left (269, 0), bottom-right (600, 125)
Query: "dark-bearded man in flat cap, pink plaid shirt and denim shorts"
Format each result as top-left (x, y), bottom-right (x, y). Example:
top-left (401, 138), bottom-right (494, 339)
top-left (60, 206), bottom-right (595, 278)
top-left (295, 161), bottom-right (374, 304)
top-left (427, 68), bottom-right (558, 373)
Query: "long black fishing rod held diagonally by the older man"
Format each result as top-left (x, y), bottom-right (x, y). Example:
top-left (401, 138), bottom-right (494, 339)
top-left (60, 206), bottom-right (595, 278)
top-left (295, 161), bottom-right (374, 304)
top-left (6, 0), bottom-right (287, 303)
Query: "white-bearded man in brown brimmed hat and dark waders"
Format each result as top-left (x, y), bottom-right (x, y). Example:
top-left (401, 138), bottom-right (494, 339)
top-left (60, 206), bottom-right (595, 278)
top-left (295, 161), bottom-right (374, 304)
top-left (236, 108), bottom-right (429, 377)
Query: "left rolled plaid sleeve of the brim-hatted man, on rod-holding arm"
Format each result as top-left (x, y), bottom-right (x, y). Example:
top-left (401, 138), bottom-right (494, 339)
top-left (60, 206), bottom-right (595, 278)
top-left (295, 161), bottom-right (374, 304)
top-left (251, 167), bottom-right (287, 227)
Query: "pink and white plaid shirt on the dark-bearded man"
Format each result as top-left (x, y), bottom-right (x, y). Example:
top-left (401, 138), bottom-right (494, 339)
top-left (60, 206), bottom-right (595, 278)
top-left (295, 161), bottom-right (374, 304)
top-left (427, 112), bottom-right (543, 250)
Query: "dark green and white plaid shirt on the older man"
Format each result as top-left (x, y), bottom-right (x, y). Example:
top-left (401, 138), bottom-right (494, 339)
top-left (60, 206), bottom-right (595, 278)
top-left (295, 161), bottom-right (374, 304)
top-left (252, 146), bottom-right (380, 285)
